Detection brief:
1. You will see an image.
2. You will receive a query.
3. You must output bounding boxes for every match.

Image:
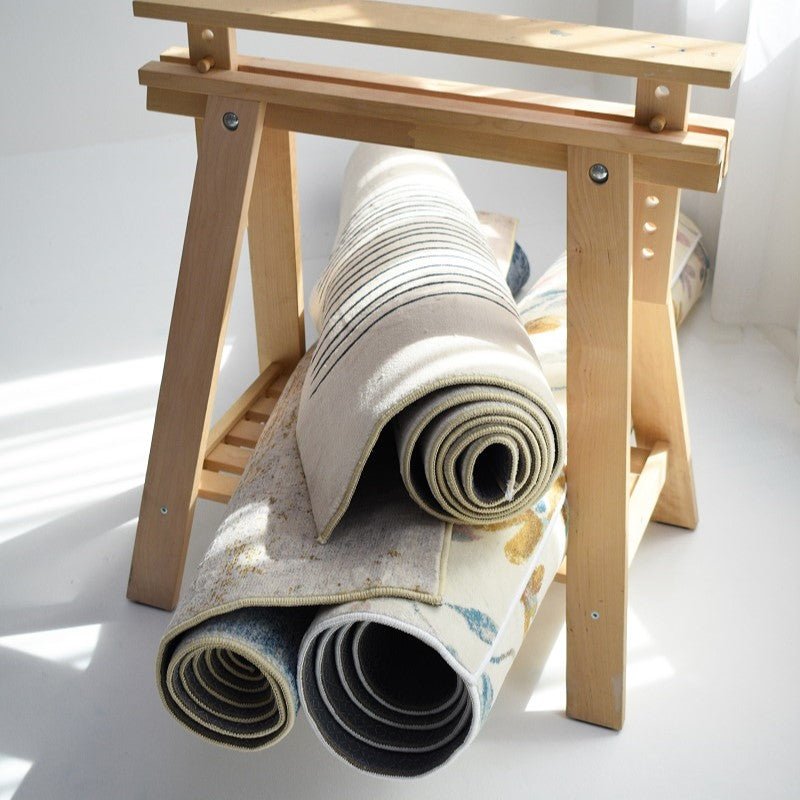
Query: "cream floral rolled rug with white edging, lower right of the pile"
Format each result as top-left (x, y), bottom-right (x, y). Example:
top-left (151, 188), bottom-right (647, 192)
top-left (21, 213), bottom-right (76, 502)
top-left (298, 475), bottom-right (566, 777)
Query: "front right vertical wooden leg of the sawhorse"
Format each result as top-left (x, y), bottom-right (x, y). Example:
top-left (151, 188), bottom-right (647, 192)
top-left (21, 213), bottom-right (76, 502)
top-left (567, 148), bottom-right (633, 729)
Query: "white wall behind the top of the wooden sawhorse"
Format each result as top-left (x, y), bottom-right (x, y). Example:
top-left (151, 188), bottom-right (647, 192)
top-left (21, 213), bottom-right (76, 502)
top-left (0, 0), bottom-right (598, 156)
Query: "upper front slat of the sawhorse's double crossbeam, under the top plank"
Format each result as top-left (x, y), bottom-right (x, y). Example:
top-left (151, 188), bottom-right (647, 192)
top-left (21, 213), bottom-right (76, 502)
top-left (139, 61), bottom-right (726, 171)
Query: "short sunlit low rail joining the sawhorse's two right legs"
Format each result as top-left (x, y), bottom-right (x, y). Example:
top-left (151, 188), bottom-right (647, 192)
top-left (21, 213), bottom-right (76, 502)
top-left (555, 442), bottom-right (669, 583)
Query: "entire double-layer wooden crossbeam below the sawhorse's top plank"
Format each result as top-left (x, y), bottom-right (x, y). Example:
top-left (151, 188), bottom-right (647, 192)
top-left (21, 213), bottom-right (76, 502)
top-left (139, 62), bottom-right (727, 192)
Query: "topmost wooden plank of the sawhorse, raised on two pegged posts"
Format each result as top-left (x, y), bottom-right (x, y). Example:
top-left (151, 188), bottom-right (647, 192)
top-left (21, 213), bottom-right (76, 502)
top-left (133, 0), bottom-right (744, 88)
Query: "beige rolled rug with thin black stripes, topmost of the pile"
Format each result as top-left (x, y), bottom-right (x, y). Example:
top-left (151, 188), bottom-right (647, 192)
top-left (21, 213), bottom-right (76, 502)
top-left (297, 145), bottom-right (564, 541)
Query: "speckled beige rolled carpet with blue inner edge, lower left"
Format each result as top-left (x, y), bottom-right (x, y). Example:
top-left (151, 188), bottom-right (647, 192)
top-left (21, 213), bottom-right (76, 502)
top-left (157, 354), bottom-right (450, 749)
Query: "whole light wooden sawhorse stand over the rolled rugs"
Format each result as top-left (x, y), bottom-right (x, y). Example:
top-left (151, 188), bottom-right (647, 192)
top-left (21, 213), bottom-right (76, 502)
top-left (128, 0), bottom-right (743, 729)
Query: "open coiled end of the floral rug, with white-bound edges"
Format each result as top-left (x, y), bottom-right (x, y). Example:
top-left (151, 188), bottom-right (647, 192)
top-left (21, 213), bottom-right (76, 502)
top-left (298, 613), bottom-right (483, 778)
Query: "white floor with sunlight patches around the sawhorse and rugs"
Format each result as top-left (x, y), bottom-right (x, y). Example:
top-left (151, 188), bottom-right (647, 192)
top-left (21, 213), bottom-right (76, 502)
top-left (0, 136), bottom-right (800, 800)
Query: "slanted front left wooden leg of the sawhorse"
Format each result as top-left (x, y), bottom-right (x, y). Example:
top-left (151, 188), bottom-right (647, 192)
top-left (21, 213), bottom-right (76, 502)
top-left (128, 97), bottom-right (264, 609)
